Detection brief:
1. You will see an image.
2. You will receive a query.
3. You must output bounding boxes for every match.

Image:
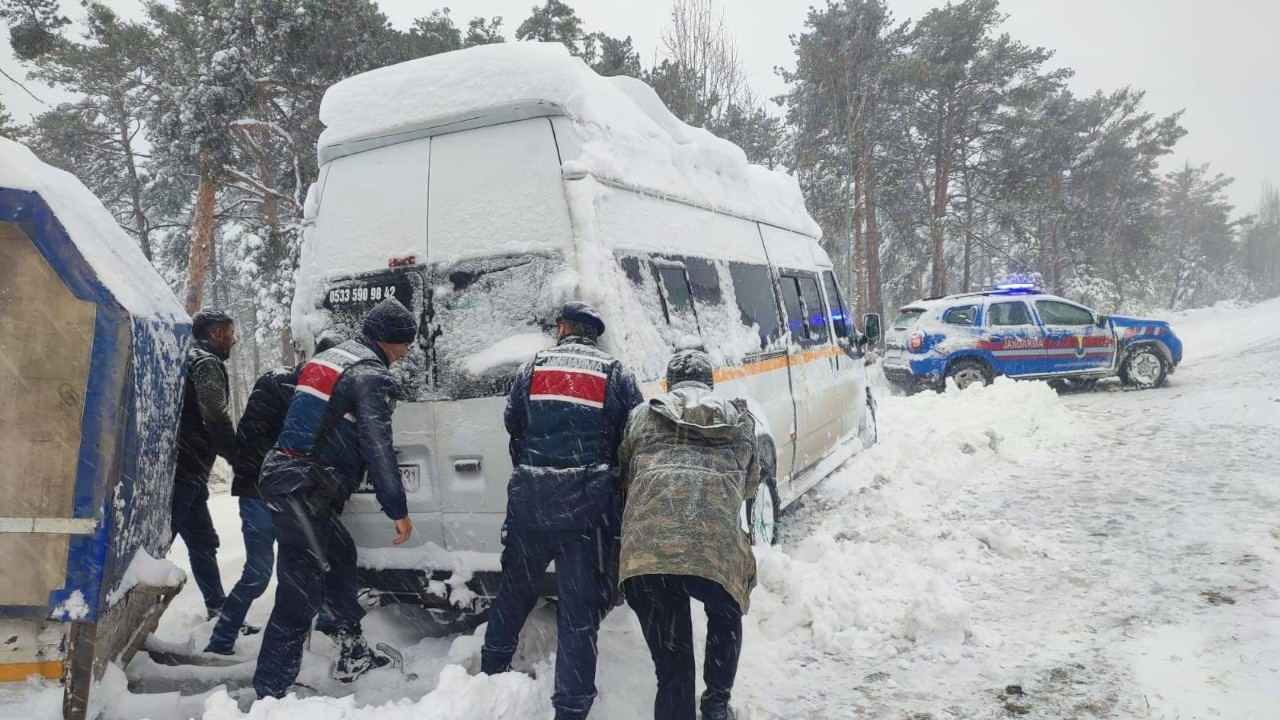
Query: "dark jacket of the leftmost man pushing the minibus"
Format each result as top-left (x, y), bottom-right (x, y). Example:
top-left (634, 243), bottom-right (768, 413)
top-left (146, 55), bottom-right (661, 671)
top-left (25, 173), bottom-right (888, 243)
top-left (175, 340), bottom-right (236, 484)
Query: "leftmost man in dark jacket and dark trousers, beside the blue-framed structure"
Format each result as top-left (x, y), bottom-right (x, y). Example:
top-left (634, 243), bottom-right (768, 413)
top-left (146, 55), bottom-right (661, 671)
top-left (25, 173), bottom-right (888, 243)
top-left (170, 310), bottom-right (236, 618)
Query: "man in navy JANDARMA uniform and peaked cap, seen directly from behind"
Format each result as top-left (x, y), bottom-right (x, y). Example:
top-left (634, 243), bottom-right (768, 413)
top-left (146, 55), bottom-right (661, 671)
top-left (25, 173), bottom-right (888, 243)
top-left (480, 301), bottom-right (644, 720)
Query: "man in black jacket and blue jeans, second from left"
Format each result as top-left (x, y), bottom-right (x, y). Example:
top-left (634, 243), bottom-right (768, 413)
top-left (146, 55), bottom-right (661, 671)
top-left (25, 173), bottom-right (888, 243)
top-left (205, 336), bottom-right (339, 655)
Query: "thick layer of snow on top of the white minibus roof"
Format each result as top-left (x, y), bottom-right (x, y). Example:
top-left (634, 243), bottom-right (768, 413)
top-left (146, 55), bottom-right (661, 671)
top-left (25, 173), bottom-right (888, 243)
top-left (319, 42), bottom-right (822, 238)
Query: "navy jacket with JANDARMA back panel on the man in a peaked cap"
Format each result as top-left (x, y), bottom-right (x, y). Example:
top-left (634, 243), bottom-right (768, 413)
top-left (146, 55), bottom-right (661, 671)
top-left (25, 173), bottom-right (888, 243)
top-left (503, 336), bottom-right (644, 530)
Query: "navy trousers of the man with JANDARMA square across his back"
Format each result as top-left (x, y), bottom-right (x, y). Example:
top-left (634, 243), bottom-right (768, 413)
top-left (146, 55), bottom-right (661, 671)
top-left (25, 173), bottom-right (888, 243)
top-left (480, 530), bottom-right (613, 719)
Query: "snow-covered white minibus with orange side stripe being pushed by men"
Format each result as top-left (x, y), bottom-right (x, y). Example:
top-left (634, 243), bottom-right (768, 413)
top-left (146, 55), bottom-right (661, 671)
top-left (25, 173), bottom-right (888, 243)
top-left (293, 44), bottom-right (876, 609)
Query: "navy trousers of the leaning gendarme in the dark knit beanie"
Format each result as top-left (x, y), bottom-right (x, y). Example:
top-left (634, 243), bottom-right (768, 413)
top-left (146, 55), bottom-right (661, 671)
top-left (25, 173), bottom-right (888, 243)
top-left (253, 500), bottom-right (365, 697)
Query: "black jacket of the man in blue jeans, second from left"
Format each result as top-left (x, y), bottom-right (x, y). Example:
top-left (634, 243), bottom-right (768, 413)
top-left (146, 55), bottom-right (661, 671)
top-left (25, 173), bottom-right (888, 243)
top-left (232, 364), bottom-right (302, 498)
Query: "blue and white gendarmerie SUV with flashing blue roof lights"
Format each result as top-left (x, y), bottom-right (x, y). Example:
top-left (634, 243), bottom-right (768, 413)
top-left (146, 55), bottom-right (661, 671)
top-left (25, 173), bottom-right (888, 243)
top-left (884, 283), bottom-right (1183, 391)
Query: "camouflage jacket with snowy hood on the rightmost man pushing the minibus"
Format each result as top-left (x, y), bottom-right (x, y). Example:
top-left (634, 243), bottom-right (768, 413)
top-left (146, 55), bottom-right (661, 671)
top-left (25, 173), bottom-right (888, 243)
top-left (618, 382), bottom-right (760, 612)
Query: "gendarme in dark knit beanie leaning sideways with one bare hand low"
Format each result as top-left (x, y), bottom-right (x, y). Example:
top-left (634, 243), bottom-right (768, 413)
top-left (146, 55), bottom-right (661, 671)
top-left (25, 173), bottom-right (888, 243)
top-left (253, 299), bottom-right (417, 697)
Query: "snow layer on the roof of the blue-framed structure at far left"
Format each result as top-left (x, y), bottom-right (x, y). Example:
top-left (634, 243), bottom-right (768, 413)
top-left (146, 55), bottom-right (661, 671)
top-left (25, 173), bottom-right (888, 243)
top-left (0, 137), bottom-right (187, 322)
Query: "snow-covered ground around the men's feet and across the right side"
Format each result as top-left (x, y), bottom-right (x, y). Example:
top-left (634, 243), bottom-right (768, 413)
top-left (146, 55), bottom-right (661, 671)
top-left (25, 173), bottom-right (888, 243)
top-left (0, 294), bottom-right (1280, 720)
